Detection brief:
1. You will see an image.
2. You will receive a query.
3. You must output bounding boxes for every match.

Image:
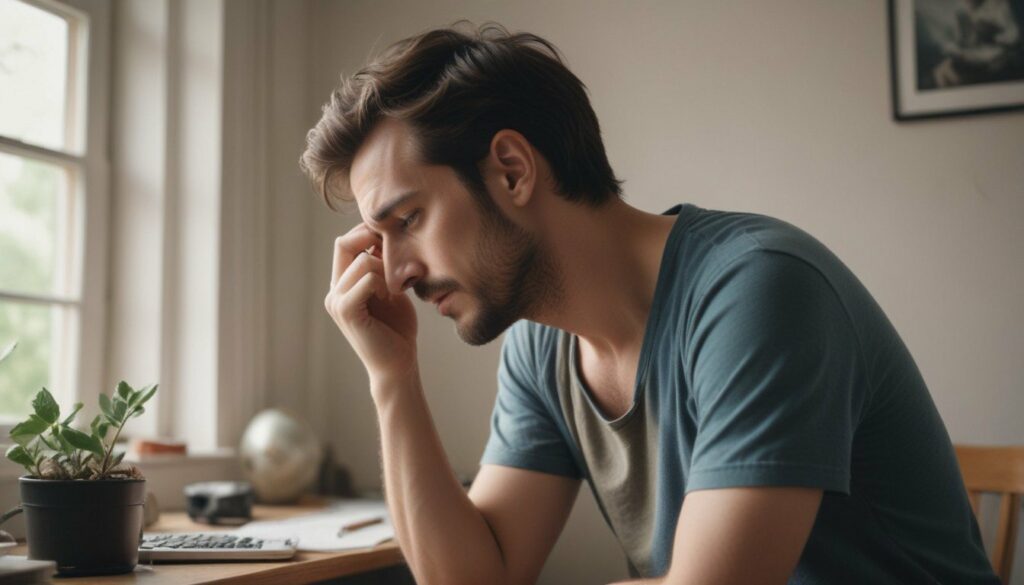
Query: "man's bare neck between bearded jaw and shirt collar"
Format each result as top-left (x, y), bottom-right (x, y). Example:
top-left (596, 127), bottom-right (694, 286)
top-left (531, 198), bottom-right (675, 359)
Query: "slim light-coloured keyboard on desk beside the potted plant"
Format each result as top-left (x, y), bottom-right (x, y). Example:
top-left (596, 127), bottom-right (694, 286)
top-left (138, 533), bottom-right (297, 562)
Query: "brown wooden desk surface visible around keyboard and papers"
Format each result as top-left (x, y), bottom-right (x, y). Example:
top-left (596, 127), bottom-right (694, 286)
top-left (10, 503), bottom-right (403, 585)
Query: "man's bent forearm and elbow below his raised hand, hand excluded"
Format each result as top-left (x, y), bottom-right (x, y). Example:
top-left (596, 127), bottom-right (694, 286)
top-left (374, 374), bottom-right (580, 585)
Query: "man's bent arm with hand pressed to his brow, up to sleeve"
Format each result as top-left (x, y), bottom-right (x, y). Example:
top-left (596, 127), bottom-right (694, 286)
top-left (324, 223), bottom-right (580, 585)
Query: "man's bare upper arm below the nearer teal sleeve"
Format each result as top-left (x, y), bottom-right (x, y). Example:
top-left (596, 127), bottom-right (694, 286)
top-left (617, 488), bottom-right (821, 585)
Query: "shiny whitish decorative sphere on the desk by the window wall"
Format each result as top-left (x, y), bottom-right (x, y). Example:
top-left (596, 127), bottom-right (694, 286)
top-left (240, 409), bottom-right (323, 504)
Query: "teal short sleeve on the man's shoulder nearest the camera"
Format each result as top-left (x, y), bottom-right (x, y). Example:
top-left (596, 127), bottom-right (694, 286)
top-left (683, 250), bottom-right (866, 493)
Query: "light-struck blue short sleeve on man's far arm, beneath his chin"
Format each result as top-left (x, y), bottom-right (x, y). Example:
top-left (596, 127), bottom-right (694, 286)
top-left (480, 323), bottom-right (582, 478)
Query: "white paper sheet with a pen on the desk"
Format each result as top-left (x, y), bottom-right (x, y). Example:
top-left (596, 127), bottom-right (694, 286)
top-left (234, 500), bottom-right (394, 552)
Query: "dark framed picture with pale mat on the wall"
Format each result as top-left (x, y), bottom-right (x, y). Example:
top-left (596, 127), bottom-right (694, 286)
top-left (889, 0), bottom-right (1024, 120)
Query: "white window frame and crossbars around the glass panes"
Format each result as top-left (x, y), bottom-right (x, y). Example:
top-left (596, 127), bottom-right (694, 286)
top-left (0, 0), bottom-right (111, 444)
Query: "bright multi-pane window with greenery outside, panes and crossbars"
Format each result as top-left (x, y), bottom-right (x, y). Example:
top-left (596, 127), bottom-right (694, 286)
top-left (0, 0), bottom-right (105, 426)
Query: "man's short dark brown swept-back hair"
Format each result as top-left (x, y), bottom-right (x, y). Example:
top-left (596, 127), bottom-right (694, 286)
top-left (299, 20), bottom-right (622, 209)
